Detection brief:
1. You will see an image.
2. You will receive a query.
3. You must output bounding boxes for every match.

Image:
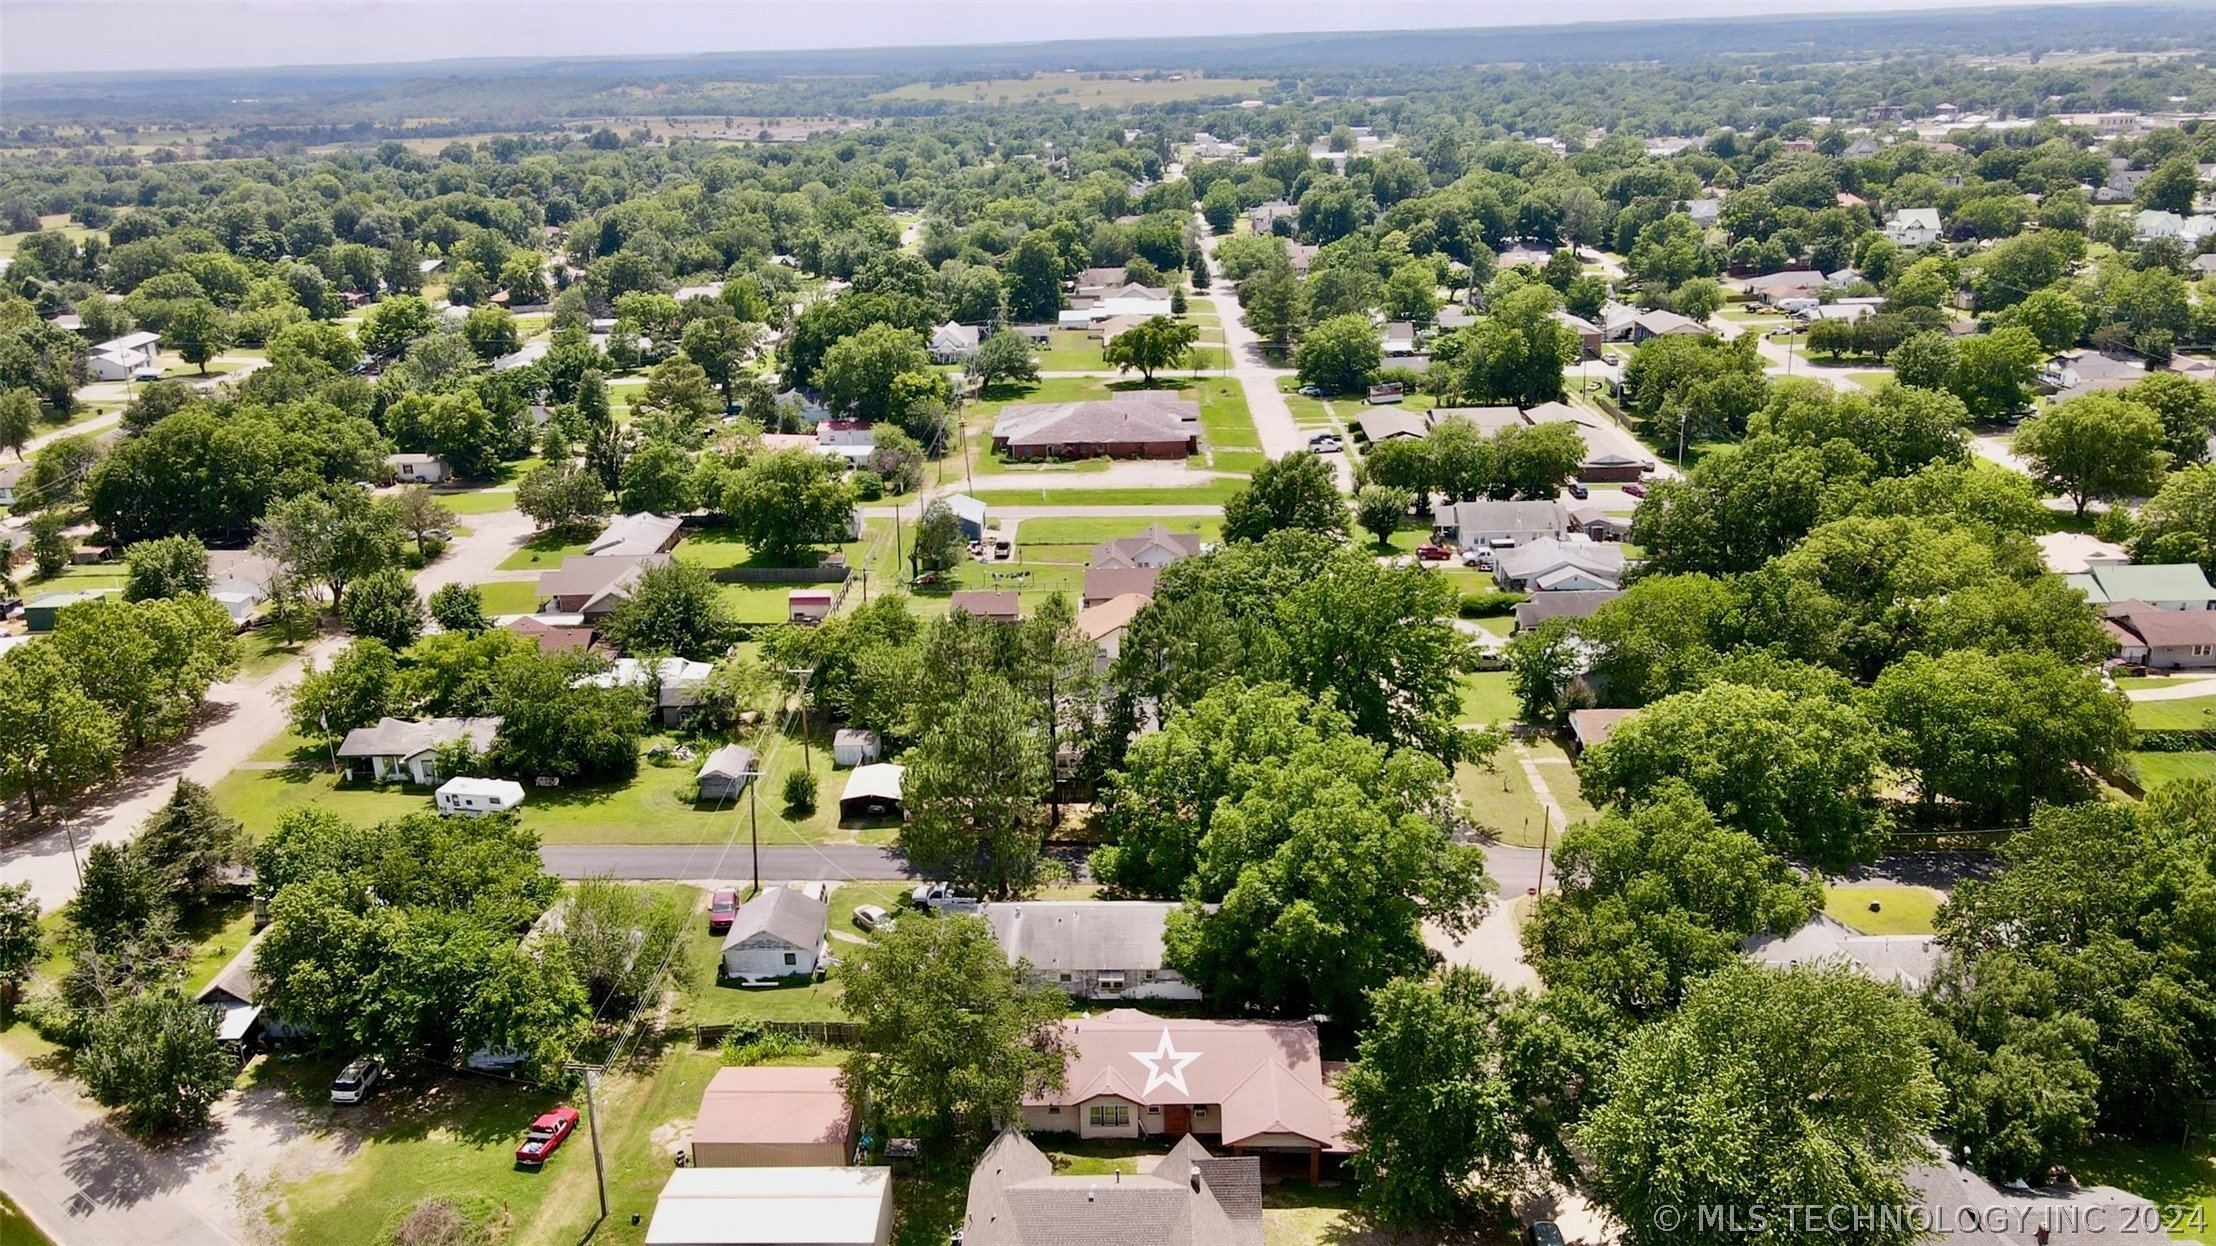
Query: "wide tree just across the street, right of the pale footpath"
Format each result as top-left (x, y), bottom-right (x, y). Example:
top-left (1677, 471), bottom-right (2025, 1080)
top-left (1578, 683), bottom-right (1886, 865)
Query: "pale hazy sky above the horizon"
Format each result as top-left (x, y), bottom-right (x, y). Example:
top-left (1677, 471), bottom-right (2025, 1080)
top-left (0, 0), bottom-right (2091, 73)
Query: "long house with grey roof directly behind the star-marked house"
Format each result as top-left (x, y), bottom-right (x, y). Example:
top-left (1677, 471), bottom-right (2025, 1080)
top-left (977, 900), bottom-right (1201, 1000)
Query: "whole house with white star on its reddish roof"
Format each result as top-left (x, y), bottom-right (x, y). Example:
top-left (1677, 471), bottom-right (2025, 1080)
top-left (1024, 1009), bottom-right (1352, 1179)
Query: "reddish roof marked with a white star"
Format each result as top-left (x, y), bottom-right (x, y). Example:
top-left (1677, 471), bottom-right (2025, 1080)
top-left (1024, 1009), bottom-right (1347, 1151)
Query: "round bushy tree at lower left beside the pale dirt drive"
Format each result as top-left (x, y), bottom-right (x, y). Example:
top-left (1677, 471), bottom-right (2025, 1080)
top-left (73, 991), bottom-right (239, 1131)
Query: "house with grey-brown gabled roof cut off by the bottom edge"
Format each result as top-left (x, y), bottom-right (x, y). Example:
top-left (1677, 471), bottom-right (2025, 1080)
top-left (957, 1128), bottom-right (1263, 1246)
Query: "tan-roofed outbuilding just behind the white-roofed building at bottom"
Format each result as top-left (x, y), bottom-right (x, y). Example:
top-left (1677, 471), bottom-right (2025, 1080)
top-left (691, 1066), bottom-right (855, 1168)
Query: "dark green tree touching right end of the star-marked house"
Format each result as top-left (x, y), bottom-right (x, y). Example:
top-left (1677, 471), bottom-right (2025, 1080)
top-left (1338, 967), bottom-right (1520, 1226)
